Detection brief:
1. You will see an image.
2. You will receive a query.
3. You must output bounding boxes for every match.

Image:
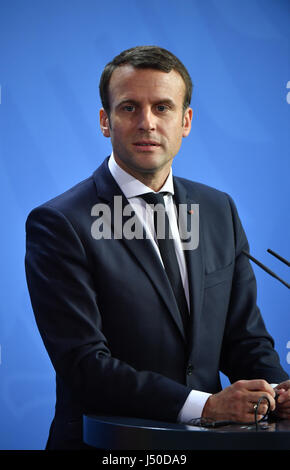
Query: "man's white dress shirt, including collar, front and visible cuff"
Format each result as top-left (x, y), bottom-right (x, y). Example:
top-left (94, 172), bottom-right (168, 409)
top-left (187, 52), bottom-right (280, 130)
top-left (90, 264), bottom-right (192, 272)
top-left (108, 153), bottom-right (210, 423)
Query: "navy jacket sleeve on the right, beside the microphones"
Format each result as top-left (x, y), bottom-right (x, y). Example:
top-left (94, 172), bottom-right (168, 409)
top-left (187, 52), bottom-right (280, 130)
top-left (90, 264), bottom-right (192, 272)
top-left (221, 197), bottom-right (288, 383)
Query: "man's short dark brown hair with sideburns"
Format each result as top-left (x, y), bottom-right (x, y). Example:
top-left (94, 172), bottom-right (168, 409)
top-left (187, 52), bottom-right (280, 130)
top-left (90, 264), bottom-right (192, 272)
top-left (99, 46), bottom-right (193, 116)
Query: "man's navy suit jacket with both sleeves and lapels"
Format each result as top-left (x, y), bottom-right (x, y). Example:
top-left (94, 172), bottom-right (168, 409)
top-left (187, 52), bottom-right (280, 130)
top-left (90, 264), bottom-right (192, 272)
top-left (26, 160), bottom-right (288, 449)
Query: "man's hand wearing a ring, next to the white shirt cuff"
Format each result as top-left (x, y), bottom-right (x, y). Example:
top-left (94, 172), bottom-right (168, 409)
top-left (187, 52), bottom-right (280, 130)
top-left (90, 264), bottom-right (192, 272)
top-left (202, 380), bottom-right (276, 423)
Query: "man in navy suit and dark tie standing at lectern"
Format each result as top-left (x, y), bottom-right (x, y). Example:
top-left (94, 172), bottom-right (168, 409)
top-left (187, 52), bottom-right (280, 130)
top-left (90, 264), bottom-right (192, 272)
top-left (26, 46), bottom-right (290, 449)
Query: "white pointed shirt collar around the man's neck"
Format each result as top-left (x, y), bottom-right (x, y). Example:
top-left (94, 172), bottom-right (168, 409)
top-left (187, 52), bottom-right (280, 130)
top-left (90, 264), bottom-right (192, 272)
top-left (108, 152), bottom-right (174, 199)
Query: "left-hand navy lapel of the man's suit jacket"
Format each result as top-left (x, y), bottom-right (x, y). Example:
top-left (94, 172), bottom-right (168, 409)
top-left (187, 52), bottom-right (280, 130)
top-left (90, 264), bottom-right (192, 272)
top-left (93, 159), bottom-right (185, 340)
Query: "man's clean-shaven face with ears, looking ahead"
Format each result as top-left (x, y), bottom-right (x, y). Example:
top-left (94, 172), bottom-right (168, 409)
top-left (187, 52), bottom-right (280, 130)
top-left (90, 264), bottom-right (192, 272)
top-left (100, 65), bottom-right (192, 180)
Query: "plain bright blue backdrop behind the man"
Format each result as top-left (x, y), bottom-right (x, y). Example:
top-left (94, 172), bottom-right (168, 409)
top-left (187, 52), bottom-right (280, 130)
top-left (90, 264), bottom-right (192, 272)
top-left (0, 0), bottom-right (290, 449)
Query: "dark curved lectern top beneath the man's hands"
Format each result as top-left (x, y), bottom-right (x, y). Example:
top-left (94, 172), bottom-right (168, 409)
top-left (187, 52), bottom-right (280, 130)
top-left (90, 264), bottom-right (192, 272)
top-left (83, 415), bottom-right (290, 450)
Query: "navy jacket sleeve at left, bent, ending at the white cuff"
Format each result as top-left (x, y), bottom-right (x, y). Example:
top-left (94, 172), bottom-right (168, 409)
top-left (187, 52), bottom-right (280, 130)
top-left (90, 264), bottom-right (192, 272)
top-left (25, 205), bottom-right (190, 421)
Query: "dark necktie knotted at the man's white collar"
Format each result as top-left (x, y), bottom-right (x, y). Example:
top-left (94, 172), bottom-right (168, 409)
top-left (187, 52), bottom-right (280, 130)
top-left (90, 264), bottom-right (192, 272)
top-left (140, 192), bottom-right (189, 333)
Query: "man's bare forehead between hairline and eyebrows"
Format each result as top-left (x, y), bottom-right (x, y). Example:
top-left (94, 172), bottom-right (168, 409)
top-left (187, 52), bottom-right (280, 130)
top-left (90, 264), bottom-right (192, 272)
top-left (109, 64), bottom-right (185, 105)
